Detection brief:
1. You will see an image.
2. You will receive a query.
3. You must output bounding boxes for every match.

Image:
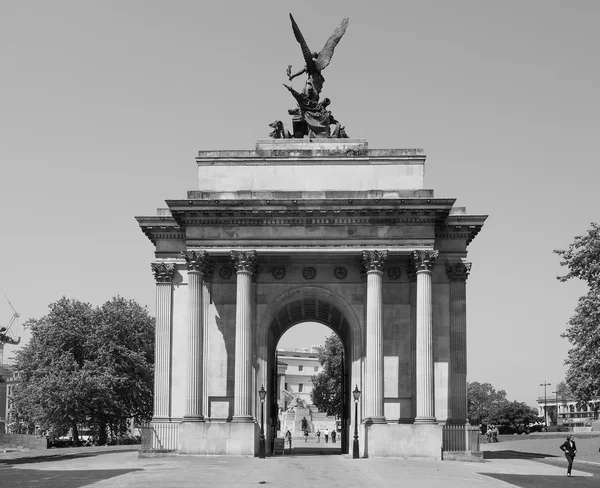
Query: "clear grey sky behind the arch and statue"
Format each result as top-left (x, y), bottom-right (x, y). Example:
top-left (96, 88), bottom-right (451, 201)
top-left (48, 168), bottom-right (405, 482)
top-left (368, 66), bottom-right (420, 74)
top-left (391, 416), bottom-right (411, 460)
top-left (0, 0), bottom-right (600, 404)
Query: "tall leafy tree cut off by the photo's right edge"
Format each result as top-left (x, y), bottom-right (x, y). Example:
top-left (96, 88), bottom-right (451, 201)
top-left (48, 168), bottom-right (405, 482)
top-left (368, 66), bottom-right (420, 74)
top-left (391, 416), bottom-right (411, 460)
top-left (554, 223), bottom-right (600, 403)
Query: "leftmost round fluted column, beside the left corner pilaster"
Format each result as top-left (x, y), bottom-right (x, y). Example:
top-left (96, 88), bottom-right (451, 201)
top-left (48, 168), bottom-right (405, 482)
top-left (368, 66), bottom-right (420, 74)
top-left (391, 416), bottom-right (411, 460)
top-left (181, 251), bottom-right (211, 422)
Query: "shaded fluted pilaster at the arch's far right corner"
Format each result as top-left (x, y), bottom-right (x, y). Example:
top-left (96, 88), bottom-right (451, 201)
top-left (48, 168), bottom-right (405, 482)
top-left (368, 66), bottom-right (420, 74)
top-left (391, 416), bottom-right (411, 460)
top-left (446, 261), bottom-right (471, 424)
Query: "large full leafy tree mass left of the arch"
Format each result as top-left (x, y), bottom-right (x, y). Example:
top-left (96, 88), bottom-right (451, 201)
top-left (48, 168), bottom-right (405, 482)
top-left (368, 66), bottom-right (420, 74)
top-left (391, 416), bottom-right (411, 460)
top-left (14, 297), bottom-right (154, 444)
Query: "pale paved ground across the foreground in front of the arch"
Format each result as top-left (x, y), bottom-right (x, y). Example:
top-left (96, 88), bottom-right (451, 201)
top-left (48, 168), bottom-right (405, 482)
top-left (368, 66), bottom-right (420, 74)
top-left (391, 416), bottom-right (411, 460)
top-left (0, 437), bottom-right (600, 488)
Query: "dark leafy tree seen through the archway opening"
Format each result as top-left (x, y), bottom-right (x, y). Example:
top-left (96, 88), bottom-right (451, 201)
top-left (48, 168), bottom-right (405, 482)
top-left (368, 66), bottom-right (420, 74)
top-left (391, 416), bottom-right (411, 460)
top-left (310, 334), bottom-right (344, 415)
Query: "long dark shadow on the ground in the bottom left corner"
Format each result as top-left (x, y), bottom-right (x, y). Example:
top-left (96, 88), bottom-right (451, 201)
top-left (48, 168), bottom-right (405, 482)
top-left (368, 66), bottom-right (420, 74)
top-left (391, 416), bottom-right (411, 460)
top-left (0, 466), bottom-right (143, 488)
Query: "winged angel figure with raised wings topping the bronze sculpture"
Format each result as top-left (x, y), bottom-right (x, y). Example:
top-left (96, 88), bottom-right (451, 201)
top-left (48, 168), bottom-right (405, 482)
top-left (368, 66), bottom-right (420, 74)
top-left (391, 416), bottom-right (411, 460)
top-left (287, 14), bottom-right (349, 102)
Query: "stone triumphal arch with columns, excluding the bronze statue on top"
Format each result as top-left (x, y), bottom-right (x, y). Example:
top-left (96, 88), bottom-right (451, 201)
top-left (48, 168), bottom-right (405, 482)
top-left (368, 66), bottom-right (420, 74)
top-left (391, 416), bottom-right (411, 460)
top-left (137, 139), bottom-right (486, 458)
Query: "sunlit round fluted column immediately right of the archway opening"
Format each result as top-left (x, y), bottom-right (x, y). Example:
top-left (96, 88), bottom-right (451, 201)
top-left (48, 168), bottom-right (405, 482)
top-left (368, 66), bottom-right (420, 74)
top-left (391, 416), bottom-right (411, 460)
top-left (361, 251), bottom-right (388, 424)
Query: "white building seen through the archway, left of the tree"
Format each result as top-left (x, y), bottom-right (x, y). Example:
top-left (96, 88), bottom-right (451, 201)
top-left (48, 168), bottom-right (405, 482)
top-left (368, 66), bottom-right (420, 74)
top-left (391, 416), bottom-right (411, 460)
top-left (277, 346), bottom-right (323, 410)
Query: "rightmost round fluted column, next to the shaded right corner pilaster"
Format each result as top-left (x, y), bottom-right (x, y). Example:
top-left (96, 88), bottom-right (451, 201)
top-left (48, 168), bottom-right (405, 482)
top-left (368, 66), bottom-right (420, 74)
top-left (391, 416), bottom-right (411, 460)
top-left (412, 251), bottom-right (438, 423)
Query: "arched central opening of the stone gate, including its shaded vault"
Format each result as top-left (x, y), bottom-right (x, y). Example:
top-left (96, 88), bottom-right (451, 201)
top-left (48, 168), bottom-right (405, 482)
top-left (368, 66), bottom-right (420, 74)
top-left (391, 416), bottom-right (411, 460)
top-left (265, 289), bottom-right (357, 454)
